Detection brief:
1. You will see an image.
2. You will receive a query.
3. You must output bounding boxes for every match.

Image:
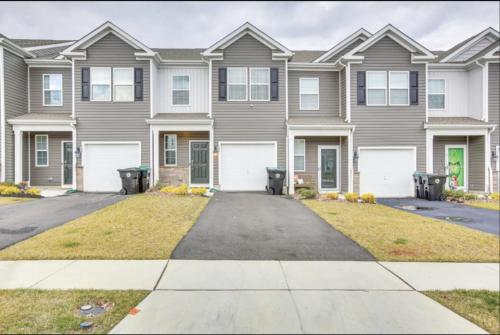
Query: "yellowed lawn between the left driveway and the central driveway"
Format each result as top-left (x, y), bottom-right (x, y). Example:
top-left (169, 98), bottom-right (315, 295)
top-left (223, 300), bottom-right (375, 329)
top-left (0, 193), bottom-right (208, 260)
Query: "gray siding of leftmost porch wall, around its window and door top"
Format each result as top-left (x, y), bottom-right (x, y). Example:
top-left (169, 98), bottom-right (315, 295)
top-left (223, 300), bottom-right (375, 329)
top-left (23, 132), bottom-right (72, 186)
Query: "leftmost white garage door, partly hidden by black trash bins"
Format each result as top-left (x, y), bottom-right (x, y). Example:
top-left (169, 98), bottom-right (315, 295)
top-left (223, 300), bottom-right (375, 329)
top-left (83, 143), bottom-right (141, 192)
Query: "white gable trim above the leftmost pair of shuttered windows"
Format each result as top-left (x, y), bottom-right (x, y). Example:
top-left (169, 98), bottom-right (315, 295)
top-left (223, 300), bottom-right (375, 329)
top-left (61, 21), bottom-right (155, 57)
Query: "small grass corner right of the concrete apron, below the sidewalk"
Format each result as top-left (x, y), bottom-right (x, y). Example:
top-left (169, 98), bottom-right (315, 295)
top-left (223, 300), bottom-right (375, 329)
top-left (424, 290), bottom-right (500, 334)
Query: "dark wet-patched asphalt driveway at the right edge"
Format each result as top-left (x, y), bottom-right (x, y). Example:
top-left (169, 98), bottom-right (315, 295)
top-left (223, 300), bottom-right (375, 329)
top-left (377, 198), bottom-right (500, 235)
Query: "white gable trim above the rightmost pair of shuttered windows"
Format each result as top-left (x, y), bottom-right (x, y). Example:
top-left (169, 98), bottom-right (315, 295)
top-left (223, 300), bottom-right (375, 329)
top-left (344, 24), bottom-right (436, 61)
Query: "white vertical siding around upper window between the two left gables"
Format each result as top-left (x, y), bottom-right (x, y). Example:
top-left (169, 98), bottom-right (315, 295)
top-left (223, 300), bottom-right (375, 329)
top-left (155, 67), bottom-right (208, 113)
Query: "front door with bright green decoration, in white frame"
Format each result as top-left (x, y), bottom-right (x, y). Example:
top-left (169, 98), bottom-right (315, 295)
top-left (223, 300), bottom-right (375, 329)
top-left (445, 145), bottom-right (467, 190)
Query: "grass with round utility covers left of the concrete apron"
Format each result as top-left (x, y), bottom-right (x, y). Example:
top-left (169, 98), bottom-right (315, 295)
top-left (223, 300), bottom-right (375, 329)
top-left (0, 290), bottom-right (149, 334)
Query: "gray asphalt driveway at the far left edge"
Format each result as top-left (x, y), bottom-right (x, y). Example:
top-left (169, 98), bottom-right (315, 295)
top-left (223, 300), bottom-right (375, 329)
top-left (0, 193), bottom-right (125, 250)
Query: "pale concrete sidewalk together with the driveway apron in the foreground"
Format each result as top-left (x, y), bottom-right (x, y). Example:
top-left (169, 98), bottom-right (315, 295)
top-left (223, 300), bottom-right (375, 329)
top-left (0, 260), bottom-right (500, 333)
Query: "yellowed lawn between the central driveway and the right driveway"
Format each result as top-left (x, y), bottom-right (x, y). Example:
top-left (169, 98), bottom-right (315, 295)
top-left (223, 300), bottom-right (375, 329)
top-left (303, 200), bottom-right (500, 262)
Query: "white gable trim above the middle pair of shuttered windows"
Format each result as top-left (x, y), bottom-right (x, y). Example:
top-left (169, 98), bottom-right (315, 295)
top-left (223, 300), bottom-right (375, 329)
top-left (202, 22), bottom-right (293, 57)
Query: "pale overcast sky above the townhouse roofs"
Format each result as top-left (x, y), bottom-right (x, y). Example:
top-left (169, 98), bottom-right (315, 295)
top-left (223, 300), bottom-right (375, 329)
top-left (0, 1), bottom-right (500, 50)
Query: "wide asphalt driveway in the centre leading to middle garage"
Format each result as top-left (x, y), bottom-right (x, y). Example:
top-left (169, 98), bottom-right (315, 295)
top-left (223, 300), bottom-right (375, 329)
top-left (172, 192), bottom-right (374, 261)
